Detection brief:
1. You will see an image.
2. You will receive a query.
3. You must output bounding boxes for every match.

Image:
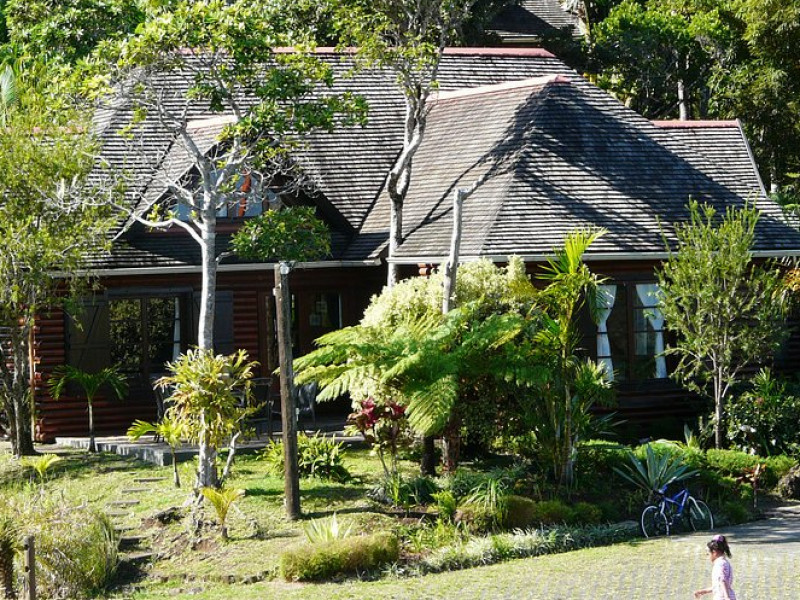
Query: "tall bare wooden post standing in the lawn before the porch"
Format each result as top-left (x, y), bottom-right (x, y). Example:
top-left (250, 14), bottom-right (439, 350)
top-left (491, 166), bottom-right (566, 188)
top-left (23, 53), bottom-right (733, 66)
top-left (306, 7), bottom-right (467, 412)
top-left (275, 262), bottom-right (300, 520)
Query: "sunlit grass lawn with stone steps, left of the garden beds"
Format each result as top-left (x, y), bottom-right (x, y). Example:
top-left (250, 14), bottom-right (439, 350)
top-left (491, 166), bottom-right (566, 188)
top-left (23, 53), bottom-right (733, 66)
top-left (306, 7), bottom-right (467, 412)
top-left (0, 440), bottom-right (416, 597)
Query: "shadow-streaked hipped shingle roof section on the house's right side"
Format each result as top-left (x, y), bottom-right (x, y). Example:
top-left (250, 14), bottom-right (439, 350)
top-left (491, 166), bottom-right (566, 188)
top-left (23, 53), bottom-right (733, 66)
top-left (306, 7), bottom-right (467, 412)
top-left (351, 77), bottom-right (800, 264)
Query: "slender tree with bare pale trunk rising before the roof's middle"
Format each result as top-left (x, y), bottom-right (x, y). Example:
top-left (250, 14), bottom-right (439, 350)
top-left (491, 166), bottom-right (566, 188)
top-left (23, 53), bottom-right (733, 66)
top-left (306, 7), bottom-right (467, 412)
top-left (339, 0), bottom-right (474, 287)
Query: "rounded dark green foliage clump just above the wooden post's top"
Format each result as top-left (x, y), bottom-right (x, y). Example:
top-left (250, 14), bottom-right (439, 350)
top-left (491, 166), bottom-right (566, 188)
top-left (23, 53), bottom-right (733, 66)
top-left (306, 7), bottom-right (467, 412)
top-left (231, 206), bottom-right (331, 262)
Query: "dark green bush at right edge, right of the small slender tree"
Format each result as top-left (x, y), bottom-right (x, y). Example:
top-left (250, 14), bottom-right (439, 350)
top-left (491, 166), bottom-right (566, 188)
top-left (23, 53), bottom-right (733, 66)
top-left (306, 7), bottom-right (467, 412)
top-left (726, 369), bottom-right (800, 456)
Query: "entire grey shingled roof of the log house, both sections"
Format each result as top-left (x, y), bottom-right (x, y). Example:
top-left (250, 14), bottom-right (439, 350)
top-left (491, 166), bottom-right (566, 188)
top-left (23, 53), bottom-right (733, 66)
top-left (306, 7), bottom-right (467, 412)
top-left (89, 48), bottom-right (800, 269)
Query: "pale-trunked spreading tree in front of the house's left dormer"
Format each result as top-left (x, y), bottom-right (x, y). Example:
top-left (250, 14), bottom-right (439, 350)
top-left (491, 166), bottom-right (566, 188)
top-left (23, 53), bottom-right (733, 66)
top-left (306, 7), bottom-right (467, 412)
top-left (84, 0), bottom-right (364, 487)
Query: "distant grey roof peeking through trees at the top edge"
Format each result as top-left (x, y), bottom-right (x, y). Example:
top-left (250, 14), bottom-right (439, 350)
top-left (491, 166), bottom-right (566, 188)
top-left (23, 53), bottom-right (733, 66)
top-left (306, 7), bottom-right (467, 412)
top-left (487, 0), bottom-right (583, 44)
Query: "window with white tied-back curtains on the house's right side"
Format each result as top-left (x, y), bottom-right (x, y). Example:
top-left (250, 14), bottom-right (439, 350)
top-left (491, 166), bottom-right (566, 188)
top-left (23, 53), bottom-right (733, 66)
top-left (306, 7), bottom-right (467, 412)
top-left (595, 283), bottom-right (667, 381)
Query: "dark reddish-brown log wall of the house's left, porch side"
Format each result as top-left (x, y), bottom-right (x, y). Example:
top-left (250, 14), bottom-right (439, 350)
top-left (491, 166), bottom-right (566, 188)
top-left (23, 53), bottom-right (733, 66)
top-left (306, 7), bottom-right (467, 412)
top-left (35, 266), bottom-right (385, 442)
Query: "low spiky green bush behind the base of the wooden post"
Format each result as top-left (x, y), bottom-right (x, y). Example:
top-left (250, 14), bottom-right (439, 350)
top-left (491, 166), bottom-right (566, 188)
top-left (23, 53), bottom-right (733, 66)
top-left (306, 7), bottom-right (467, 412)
top-left (262, 433), bottom-right (352, 483)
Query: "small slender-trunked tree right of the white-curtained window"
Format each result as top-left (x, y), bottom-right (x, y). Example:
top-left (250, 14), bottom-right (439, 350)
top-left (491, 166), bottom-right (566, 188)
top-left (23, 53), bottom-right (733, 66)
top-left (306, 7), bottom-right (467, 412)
top-left (656, 202), bottom-right (789, 448)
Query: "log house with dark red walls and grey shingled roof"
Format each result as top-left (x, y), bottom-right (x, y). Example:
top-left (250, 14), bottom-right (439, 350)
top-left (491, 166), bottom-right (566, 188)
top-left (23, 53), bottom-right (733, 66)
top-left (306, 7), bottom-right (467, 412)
top-left (28, 48), bottom-right (800, 439)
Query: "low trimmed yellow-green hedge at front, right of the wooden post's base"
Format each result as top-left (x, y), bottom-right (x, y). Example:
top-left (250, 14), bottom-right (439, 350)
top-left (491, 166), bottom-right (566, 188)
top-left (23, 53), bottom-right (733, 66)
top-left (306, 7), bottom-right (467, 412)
top-left (280, 532), bottom-right (400, 581)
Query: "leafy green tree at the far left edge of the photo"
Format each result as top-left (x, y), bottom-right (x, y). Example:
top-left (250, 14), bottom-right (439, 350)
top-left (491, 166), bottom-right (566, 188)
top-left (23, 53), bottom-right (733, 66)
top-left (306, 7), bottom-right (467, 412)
top-left (0, 80), bottom-right (116, 456)
